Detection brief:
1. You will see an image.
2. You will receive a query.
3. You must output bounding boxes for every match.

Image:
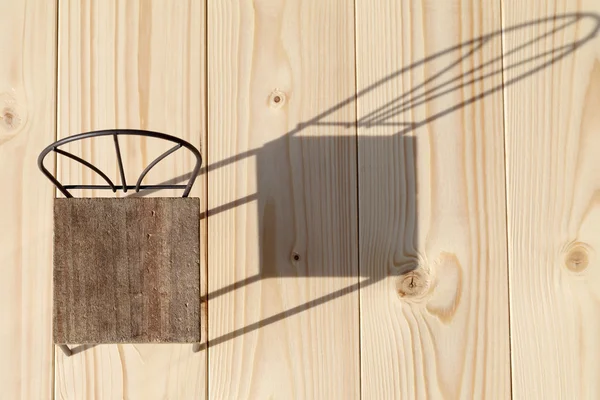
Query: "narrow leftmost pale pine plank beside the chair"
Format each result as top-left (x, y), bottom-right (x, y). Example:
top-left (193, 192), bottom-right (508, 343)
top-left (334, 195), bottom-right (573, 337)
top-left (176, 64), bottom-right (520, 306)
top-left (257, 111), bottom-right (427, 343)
top-left (0, 0), bottom-right (56, 399)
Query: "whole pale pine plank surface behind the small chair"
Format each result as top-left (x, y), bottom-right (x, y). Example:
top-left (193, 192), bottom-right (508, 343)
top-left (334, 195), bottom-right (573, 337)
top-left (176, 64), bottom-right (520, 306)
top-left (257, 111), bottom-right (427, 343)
top-left (0, 0), bottom-right (600, 399)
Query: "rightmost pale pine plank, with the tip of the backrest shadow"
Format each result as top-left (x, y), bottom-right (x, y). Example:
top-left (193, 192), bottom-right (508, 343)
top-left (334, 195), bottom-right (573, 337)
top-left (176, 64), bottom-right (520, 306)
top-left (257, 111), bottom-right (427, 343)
top-left (503, 4), bottom-right (600, 399)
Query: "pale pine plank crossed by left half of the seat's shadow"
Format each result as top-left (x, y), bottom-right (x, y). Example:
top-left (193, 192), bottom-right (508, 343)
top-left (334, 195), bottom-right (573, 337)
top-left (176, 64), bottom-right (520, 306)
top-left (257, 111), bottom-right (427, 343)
top-left (208, 0), bottom-right (359, 399)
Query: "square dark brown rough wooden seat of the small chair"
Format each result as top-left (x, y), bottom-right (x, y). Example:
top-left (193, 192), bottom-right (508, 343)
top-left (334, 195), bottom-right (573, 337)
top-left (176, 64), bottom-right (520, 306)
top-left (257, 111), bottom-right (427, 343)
top-left (54, 198), bottom-right (200, 344)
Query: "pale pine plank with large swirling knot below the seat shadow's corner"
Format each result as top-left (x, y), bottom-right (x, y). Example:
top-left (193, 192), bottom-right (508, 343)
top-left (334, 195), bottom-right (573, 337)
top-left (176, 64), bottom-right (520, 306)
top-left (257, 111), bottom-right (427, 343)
top-left (356, 0), bottom-right (510, 399)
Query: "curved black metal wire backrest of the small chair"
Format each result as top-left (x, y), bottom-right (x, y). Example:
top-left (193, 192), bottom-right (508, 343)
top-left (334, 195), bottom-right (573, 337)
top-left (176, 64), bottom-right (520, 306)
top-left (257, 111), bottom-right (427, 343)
top-left (38, 129), bottom-right (202, 197)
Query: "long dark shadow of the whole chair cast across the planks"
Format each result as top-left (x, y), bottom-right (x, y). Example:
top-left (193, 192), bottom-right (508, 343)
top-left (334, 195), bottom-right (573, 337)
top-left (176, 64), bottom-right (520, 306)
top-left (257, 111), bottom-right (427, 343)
top-left (59, 13), bottom-right (600, 353)
